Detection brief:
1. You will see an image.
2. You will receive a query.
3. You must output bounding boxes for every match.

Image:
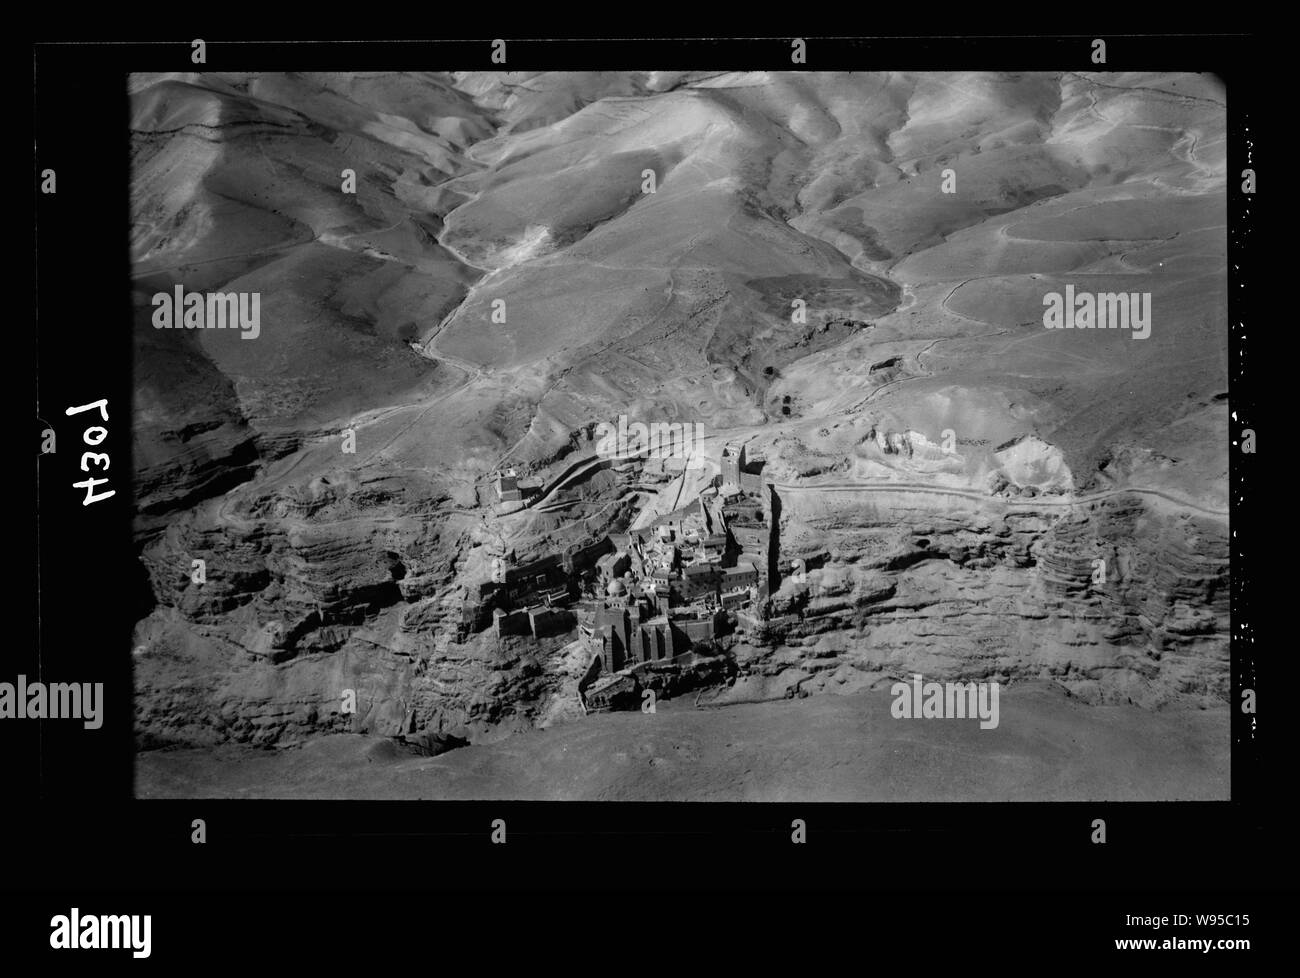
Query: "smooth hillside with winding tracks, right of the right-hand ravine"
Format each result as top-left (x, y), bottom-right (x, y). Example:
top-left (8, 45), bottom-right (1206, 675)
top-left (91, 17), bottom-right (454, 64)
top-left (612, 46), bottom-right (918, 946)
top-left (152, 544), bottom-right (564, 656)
top-left (743, 68), bottom-right (1227, 505)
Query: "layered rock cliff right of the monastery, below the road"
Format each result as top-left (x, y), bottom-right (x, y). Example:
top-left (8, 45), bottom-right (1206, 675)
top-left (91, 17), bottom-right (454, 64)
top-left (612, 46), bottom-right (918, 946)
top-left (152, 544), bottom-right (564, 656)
top-left (742, 496), bottom-right (1230, 706)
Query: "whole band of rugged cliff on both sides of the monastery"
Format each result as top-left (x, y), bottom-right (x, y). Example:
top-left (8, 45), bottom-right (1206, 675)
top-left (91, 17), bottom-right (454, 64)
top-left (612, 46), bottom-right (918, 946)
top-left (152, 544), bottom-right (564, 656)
top-left (137, 457), bottom-right (1229, 745)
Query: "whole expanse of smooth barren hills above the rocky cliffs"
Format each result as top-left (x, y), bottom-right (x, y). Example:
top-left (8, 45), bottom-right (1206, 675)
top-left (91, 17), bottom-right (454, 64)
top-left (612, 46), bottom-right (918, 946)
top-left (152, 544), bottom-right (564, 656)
top-left (131, 72), bottom-right (1226, 512)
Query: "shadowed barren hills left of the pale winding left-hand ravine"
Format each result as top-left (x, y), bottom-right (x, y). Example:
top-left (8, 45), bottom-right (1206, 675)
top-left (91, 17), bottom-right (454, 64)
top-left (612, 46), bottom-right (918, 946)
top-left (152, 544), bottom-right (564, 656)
top-left (131, 74), bottom-right (490, 505)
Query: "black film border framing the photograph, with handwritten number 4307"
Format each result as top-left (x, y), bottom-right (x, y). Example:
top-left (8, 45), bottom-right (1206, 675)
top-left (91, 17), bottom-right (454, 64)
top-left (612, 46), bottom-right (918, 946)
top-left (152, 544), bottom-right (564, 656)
top-left (20, 32), bottom-right (1269, 915)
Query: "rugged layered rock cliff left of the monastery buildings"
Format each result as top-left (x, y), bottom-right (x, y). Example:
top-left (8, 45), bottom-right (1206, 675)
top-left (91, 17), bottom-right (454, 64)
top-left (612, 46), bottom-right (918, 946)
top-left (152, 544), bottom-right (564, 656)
top-left (135, 465), bottom-right (598, 747)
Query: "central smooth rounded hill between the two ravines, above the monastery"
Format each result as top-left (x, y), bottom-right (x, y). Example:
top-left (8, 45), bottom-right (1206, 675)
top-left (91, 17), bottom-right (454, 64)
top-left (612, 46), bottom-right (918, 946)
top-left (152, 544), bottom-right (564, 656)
top-left (429, 91), bottom-right (898, 447)
